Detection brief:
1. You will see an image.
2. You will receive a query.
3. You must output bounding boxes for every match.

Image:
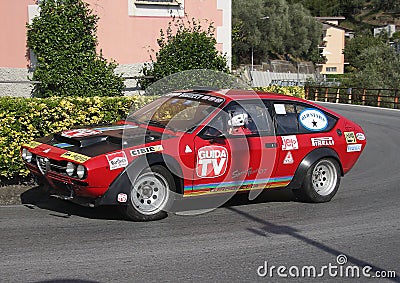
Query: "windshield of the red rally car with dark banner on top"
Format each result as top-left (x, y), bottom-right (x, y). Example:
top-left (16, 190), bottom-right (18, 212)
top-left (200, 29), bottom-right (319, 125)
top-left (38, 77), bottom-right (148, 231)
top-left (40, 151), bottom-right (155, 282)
top-left (128, 92), bottom-right (224, 132)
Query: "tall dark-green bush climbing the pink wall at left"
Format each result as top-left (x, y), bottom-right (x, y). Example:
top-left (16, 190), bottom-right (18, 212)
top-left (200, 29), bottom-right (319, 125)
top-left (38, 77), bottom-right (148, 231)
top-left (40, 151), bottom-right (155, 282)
top-left (27, 0), bottom-right (124, 97)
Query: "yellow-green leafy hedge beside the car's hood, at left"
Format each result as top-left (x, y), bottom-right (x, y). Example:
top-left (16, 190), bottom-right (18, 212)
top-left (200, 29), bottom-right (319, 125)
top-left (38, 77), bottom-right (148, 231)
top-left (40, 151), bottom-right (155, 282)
top-left (0, 96), bottom-right (154, 179)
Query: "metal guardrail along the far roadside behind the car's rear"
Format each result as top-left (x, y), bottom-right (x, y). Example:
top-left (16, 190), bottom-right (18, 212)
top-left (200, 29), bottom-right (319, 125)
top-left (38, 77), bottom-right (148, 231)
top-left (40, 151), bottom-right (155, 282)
top-left (305, 86), bottom-right (400, 109)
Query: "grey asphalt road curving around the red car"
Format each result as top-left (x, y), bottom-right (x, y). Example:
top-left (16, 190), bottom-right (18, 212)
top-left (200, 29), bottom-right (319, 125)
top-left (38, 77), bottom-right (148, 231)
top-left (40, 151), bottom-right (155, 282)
top-left (0, 104), bottom-right (400, 282)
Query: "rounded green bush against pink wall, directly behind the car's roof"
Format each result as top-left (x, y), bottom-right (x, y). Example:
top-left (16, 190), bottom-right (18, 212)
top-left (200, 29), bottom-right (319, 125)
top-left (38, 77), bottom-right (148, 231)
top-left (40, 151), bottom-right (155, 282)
top-left (139, 17), bottom-right (229, 89)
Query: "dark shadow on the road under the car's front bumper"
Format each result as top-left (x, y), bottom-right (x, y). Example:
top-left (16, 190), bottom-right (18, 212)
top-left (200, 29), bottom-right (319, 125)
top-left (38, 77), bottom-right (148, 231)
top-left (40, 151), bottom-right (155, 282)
top-left (20, 186), bottom-right (126, 220)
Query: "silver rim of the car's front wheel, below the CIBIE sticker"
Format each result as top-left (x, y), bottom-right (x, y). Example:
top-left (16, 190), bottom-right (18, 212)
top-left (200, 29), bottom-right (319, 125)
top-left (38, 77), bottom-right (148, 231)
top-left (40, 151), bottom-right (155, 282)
top-left (131, 172), bottom-right (169, 215)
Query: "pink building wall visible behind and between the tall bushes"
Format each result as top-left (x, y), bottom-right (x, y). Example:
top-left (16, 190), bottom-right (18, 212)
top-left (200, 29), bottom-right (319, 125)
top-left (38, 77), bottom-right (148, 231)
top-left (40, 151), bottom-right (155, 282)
top-left (0, 0), bottom-right (230, 68)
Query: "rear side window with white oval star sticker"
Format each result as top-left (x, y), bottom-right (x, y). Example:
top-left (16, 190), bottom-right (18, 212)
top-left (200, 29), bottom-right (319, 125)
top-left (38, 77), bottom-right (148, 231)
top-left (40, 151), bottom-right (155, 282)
top-left (274, 102), bottom-right (337, 135)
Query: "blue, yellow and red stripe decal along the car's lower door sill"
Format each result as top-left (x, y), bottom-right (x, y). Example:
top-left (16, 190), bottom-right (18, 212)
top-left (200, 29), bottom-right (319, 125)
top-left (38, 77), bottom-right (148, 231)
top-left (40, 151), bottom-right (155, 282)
top-left (183, 176), bottom-right (293, 197)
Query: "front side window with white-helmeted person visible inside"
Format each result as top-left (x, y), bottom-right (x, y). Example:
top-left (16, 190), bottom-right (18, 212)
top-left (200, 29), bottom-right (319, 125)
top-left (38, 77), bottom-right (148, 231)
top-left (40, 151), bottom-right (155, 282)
top-left (202, 102), bottom-right (273, 136)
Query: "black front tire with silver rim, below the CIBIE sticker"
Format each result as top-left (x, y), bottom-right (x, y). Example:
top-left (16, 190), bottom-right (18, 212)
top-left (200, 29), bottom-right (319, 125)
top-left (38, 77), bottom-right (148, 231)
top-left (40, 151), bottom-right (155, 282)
top-left (121, 165), bottom-right (176, 221)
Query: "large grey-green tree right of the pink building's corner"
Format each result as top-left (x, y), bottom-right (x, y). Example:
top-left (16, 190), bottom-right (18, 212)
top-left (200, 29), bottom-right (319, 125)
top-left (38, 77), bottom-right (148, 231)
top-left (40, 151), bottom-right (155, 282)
top-left (232, 0), bottom-right (322, 64)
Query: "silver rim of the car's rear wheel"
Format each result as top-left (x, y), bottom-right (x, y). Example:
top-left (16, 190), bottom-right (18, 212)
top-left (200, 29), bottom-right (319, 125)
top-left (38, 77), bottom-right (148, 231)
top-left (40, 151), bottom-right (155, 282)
top-left (312, 159), bottom-right (338, 196)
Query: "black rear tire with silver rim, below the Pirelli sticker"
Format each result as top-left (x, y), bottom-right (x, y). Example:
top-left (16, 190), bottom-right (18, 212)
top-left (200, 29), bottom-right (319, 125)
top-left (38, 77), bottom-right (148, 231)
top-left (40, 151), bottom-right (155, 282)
top-left (293, 158), bottom-right (341, 203)
